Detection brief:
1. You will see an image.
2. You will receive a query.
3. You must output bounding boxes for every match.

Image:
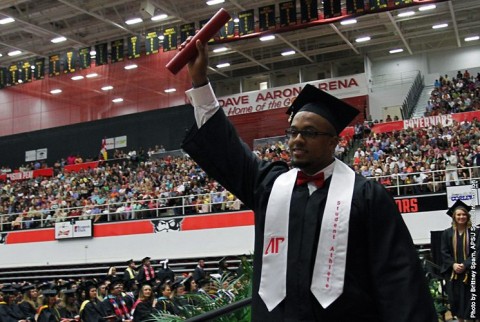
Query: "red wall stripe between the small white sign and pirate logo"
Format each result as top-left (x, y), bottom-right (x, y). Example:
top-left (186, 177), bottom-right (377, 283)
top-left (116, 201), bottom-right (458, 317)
top-left (93, 220), bottom-right (153, 237)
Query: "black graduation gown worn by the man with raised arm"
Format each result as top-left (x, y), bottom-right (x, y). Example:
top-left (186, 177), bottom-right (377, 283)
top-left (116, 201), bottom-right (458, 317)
top-left (183, 109), bottom-right (437, 322)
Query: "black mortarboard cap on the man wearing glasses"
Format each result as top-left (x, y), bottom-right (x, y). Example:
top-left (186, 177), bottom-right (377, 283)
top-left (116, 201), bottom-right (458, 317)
top-left (287, 84), bottom-right (359, 134)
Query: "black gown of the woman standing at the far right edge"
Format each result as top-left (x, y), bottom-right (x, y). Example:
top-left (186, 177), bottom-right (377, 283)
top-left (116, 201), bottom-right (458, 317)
top-left (441, 227), bottom-right (480, 319)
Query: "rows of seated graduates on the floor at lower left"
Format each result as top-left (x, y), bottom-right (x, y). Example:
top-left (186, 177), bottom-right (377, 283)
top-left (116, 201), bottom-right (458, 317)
top-left (0, 257), bottom-right (250, 322)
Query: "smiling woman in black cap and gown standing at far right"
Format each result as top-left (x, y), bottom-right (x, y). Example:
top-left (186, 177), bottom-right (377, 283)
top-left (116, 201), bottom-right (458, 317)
top-left (441, 200), bottom-right (480, 322)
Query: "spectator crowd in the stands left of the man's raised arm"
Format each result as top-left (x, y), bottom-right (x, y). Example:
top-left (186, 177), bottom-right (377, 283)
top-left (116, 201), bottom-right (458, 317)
top-left (0, 145), bottom-right (241, 231)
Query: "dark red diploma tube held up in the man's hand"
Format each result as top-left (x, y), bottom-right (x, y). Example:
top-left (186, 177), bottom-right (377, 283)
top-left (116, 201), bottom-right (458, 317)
top-left (165, 8), bottom-right (231, 74)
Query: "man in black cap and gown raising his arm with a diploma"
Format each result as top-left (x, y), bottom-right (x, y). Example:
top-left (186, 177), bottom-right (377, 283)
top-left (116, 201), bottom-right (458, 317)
top-left (181, 41), bottom-right (437, 322)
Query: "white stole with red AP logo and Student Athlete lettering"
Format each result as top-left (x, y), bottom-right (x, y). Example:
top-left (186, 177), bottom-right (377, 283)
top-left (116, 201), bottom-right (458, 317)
top-left (258, 160), bottom-right (355, 311)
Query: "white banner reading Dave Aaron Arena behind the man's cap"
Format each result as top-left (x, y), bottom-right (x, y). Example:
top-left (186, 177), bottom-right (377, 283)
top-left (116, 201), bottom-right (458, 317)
top-left (218, 73), bottom-right (368, 116)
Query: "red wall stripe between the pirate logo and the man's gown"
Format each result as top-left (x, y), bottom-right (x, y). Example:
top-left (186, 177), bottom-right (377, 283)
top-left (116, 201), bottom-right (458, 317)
top-left (181, 211), bottom-right (254, 230)
